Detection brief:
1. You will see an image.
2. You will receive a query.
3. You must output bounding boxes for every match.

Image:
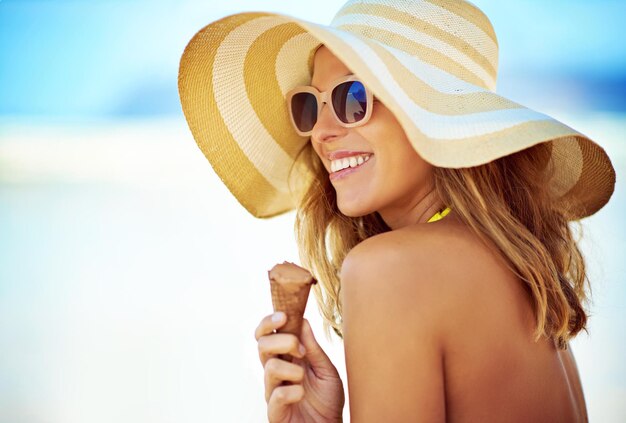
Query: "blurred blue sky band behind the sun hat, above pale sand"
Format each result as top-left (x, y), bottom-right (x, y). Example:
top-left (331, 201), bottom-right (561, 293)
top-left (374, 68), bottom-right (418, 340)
top-left (0, 0), bottom-right (626, 118)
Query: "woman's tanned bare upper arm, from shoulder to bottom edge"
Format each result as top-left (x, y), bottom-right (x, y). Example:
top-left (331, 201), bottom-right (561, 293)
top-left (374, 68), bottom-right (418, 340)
top-left (341, 234), bottom-right (446, 423)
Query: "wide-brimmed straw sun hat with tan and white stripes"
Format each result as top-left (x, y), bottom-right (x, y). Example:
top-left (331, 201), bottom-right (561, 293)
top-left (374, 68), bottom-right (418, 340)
top-left (178, 0), bottom-right (615, 218)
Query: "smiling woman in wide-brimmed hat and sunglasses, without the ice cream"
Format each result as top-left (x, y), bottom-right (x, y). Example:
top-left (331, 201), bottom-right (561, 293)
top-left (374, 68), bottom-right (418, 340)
top-left (179, 0), bottom-right (615, 422)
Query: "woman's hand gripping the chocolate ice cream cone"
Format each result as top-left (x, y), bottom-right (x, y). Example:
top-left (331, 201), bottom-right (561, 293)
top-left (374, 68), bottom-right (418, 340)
top-left (254, 312), bottom-right (345, 423)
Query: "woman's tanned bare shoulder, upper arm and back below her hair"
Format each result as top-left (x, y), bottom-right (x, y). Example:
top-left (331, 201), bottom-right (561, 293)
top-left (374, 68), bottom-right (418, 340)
top-left (340, 217), bottom-right (585, 422)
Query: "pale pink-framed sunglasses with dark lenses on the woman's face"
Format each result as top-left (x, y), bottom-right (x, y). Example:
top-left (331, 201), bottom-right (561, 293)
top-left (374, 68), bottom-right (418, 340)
top-left (287, 75), bottom-right (374, 137)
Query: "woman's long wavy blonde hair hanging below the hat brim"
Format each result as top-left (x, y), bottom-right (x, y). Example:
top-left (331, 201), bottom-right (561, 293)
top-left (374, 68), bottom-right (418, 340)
top-left (294, 143), bottom-right (590, 349)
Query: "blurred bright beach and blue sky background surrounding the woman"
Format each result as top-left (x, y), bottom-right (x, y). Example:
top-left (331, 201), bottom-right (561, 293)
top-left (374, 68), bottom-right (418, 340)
top-left (0, 0), bottom-right (626, 423)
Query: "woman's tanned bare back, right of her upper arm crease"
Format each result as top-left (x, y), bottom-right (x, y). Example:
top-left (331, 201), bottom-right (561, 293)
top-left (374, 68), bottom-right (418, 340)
top-left (409, 219), bottom-right (587, 422)
